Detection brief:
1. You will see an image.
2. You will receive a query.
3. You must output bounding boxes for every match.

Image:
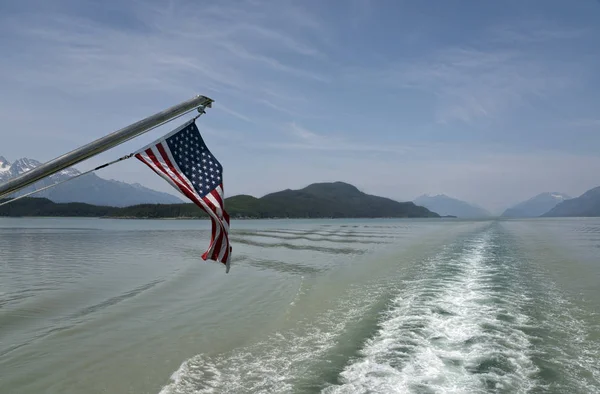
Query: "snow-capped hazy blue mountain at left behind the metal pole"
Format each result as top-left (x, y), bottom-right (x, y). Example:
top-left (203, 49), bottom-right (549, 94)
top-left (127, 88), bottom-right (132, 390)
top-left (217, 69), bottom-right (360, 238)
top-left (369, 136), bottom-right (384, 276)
top-left (0, 156), bottom-right (182, 207)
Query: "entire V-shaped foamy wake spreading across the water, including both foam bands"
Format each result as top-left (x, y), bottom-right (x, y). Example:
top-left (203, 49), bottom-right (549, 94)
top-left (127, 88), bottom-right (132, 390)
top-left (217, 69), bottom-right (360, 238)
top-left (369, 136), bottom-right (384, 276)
top-left (156, 225), bottom-right (600, 394)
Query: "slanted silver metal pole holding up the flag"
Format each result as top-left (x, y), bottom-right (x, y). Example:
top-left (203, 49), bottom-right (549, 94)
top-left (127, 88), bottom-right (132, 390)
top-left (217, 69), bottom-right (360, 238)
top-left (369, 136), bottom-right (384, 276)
top-left (0, 96), bottom-right (213, 198)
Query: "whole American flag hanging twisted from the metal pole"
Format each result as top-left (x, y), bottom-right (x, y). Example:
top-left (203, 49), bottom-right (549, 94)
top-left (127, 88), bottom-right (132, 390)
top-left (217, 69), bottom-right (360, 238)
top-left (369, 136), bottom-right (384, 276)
top-left (135, 120), bottom-right (231, 272)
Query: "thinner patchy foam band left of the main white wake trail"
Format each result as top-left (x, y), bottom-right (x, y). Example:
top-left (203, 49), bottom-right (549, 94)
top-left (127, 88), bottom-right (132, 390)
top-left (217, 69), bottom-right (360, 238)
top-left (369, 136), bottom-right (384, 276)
top-left (160, 282), bottom-right (386, 394)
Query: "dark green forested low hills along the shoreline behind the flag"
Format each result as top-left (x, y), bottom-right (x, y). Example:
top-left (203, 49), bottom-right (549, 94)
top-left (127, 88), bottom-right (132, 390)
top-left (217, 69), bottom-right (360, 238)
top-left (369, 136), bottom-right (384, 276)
top-left (0, 182), bottom-right (439, 218)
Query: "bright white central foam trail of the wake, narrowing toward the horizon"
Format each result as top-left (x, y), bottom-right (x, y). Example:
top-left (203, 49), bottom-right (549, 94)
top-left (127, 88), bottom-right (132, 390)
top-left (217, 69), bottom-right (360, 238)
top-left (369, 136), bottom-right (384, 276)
top-left (324, 234), bottom-right (536, 393)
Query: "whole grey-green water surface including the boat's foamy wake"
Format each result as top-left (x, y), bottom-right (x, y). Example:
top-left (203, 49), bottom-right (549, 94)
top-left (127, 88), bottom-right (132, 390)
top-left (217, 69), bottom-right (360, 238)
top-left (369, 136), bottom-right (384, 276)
top-left (0, 218), bottom-right (600, 394)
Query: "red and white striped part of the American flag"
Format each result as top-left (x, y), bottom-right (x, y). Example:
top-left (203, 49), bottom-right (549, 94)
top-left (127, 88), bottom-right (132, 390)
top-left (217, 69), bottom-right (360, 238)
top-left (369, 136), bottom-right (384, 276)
top-left (135, 140), bottom-right (231, 272)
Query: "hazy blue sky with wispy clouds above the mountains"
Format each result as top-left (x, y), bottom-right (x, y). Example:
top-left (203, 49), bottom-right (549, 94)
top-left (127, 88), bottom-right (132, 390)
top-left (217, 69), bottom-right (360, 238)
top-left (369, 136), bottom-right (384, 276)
top-left (0, 0), bottom-right (600, 212)
